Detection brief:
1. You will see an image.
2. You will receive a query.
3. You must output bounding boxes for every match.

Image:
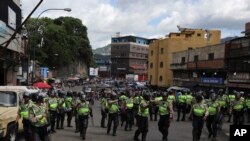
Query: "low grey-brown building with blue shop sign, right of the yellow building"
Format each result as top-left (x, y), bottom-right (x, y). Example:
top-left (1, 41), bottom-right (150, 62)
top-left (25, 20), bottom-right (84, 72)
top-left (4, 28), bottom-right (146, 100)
top-left (171, 44), bottom-right (227, 87)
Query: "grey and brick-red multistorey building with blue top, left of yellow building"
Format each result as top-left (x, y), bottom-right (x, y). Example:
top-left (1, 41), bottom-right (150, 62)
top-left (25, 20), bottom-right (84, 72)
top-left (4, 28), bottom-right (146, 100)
top-left (111, 35), bottom-right (150, 80)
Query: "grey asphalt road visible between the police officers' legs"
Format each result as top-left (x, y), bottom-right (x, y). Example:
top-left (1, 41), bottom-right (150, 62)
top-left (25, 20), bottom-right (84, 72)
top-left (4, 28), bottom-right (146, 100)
top-left (18, 87), bottom-right (229, 141)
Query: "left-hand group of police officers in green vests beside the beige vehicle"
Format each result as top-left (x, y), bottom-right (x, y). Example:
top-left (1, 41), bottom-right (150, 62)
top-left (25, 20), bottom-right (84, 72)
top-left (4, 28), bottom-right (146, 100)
top-left (16, 90), bottom-right (93, 141)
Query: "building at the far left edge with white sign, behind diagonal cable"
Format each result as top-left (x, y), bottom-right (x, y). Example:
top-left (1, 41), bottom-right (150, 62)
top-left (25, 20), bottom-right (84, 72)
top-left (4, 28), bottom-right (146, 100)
top-left (0, 0), bottom-right (24, 85)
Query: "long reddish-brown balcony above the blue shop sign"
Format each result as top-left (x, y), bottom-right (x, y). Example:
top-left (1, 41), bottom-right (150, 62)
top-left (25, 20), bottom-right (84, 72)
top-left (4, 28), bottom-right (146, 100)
top-left (187, 59), bottom-right (225, 69)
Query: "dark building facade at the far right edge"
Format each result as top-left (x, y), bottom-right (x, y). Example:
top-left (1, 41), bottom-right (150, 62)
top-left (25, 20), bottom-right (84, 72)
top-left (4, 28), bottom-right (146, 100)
top-left (226, 22), bottom-right (250, 92)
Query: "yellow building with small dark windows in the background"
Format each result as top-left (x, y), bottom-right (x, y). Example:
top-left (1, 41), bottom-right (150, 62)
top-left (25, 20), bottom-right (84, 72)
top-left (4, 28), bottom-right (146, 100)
top-left (148, 28), bottom-right (221, 87)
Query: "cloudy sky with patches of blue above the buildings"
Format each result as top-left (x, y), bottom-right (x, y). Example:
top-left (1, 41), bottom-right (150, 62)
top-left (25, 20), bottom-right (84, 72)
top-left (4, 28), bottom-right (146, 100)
top-left (21, 0), bottom-right (250, 49)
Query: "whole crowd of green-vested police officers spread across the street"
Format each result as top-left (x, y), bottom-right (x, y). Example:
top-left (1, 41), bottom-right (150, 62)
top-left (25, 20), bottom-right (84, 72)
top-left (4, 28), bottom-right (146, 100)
top-left (16, 85), bottom-right (250, 141)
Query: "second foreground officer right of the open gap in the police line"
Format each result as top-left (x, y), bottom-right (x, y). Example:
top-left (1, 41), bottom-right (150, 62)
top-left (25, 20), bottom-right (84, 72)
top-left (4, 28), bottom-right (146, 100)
top-left (107, 92), bottom-right (119, 136)
